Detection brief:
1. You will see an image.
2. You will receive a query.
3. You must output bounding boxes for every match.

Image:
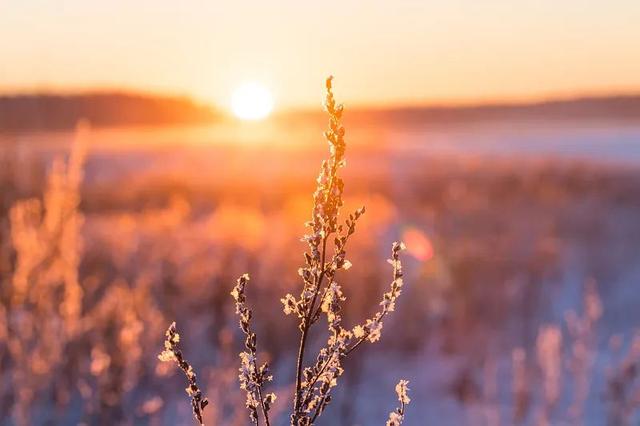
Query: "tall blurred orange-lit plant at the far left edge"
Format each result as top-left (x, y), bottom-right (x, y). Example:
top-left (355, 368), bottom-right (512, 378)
top-left (2, 124), bottom-right (87, 424)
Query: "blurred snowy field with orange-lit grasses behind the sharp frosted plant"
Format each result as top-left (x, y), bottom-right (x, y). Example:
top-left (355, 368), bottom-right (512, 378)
top-left (0, 118), bottom-right (640, 426)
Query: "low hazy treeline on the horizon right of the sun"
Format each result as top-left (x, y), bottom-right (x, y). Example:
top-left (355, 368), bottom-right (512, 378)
top-left (282, 95), bottom-right (640, 125)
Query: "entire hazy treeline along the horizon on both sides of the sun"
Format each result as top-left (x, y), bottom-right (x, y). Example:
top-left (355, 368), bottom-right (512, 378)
top-left (0, 93), bottom-right (640, 131)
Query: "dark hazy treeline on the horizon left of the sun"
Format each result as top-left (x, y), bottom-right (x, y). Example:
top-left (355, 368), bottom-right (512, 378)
top-left (0, 93), bottom-right (218, 131)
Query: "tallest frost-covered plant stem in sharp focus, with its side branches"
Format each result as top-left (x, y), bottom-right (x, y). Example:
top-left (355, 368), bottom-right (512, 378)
top-left (282, 77), bottom-right (404, 426)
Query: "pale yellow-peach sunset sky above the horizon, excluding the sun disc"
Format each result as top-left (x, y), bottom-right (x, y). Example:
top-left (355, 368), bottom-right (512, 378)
top-left (0, 0), bottom-right (640, 108)
